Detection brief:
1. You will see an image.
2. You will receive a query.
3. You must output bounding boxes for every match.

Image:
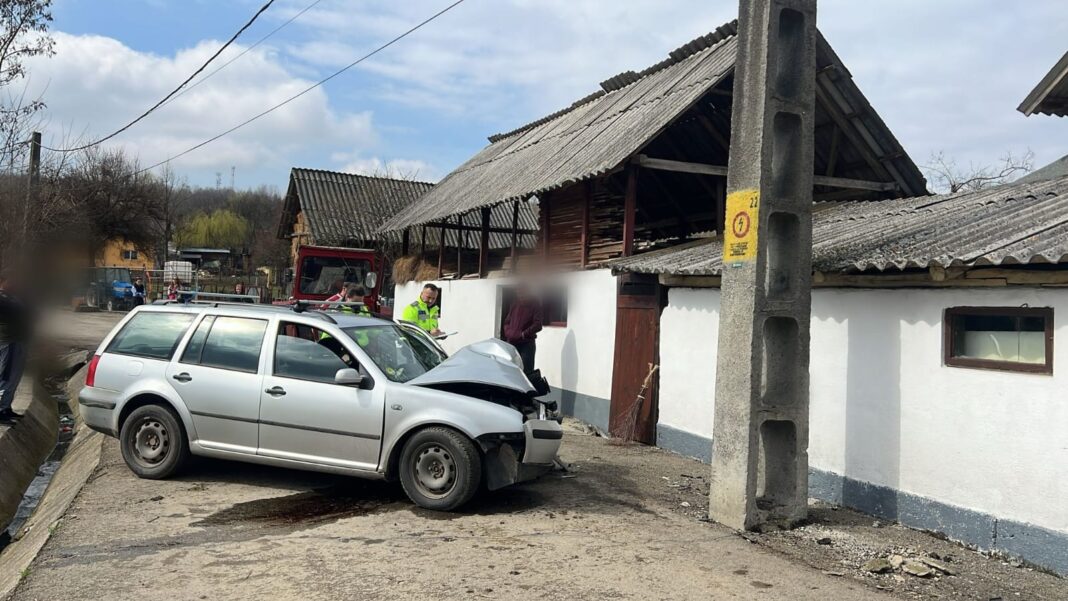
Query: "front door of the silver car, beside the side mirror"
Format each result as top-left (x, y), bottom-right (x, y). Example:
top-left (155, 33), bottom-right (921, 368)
top-left (260, 321), bottom-right (384, 470)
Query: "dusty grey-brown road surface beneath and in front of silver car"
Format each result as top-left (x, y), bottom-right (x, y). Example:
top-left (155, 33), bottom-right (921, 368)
top-left (15, 434), bottom-right (888, 601)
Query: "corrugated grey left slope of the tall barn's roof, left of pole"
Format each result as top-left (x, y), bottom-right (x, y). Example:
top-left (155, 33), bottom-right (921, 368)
top-left (382, 23), bottom-right (735, 230)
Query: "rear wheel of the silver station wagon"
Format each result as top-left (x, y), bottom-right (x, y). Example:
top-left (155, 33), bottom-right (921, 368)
top-left (119, 405), bottom-right (189, 480)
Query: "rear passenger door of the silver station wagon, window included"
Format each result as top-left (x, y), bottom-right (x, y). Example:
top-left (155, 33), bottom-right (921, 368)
top-left (168, 315), bottom-right (268, 455)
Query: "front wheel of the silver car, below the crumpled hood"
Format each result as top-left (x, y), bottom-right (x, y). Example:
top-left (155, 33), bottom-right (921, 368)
top-left (399, 427), bottom-right (482, 511)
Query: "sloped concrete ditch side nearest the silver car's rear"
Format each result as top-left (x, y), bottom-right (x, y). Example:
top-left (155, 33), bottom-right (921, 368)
top-left (0, 368), bottom-right (104, 599)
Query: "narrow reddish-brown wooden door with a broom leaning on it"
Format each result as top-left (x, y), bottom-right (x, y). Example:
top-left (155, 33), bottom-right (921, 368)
top-left (609, 275), bottom-right (661, 444)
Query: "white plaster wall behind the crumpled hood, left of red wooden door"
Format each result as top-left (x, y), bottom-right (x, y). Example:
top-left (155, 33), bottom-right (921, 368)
top-left (394, 269), bottom-right (616, 399)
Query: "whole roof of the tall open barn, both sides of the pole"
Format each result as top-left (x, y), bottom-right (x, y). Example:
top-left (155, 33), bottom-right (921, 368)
top-left (382, 21), bottom-right (926, 231)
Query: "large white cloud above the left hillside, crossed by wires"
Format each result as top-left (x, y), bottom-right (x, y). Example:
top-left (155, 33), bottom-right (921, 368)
top-left (20, 32), bottom-right (378, 177)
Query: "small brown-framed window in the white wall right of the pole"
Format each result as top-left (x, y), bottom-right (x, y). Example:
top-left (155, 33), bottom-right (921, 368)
top-left (943, 306), bottom-right (1053, 374)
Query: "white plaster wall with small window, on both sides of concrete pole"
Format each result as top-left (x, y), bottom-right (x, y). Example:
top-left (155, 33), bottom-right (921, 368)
top-left (660, 288), bottom-right (1068, 532)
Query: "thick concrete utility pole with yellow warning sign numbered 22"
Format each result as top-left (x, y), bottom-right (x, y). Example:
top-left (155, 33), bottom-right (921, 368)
top-left (709, 0), bottom-right (816, 529)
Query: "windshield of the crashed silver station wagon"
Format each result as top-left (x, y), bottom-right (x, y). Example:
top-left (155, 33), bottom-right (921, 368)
top-left (345, 326), bottom-right (445, 382)
